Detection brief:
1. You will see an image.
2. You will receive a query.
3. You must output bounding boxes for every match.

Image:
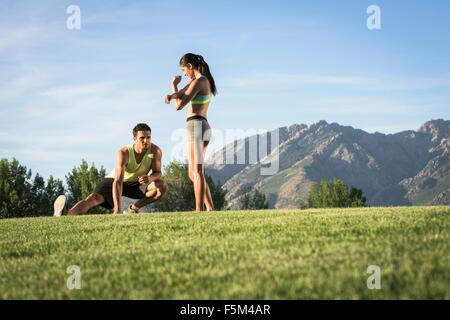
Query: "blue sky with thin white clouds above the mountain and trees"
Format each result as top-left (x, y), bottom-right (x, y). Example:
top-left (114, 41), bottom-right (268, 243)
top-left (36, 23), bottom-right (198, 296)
top-left (0, 0), bottom-right (450, 178)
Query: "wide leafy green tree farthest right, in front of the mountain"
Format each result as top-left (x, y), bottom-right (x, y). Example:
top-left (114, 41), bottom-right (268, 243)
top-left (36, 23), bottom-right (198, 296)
top-left (308, 179), bottom-right (366, 208)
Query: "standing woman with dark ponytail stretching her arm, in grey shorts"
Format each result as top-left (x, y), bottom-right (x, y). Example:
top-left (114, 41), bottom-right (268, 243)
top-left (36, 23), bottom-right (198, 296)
top-left (165, 53), bottom-right (217, 211)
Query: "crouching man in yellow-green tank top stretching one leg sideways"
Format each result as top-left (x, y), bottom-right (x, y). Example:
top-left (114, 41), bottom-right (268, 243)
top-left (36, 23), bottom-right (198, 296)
top-left (54, 123), bottom-right (168, 216)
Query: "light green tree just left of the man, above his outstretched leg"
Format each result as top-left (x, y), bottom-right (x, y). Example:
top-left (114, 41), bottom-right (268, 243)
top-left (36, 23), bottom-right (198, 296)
top-left (66, 159), bottom-right (106, 212)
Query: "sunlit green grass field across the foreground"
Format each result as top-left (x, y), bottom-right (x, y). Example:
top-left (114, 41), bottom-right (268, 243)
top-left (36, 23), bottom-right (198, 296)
top-left (0, 207), bottom-right (450, 299)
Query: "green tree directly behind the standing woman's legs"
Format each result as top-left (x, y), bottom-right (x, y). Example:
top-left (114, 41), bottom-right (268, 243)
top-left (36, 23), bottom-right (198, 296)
top-left (153, 161), bottom-right (226, 211)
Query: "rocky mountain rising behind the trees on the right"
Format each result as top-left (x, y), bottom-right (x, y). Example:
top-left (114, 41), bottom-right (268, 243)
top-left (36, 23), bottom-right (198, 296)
top-left (206, 119), bottom-right (450, 208)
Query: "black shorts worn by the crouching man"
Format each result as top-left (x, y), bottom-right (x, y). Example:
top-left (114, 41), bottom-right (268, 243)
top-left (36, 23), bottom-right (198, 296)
top-left (94, 178), bottom-right (148, 209)
